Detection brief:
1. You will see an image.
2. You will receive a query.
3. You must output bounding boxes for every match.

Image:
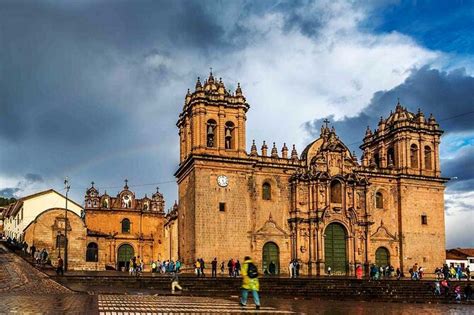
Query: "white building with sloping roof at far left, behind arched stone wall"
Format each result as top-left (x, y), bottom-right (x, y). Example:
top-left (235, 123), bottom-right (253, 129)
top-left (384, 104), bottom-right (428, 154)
top-left (3, 189), bottom-right (83, 241)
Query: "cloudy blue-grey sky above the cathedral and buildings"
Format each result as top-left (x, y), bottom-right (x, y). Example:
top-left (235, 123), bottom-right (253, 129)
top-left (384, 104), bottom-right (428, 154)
top-left (0, 0), bottom-right (474, 247)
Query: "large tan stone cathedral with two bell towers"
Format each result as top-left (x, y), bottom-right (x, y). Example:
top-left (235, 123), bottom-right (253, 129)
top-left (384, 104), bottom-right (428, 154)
top-left (173, 73), bottom-right (447, 275)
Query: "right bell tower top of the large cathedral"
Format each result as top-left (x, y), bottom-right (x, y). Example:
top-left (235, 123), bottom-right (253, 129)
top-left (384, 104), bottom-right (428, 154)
top-left (360, 102), bottom-right (443, 177)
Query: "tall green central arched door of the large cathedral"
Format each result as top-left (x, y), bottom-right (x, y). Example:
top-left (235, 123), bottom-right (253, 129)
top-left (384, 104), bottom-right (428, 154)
top-left (324, 223), bottom-right (347, 274)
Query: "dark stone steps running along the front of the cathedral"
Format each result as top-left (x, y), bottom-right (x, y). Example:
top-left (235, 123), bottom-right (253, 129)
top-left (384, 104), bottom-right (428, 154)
top-left (52, 275), bottom-right (473, 304)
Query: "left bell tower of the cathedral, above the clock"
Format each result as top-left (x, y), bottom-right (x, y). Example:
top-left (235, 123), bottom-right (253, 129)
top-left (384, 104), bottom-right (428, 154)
top-left (176, 70), bottom-right (249, 164)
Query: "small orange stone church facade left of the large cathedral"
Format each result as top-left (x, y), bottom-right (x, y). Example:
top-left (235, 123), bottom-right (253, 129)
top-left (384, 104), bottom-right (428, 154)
top-left (84, 181), bottom-right (166, 270)
